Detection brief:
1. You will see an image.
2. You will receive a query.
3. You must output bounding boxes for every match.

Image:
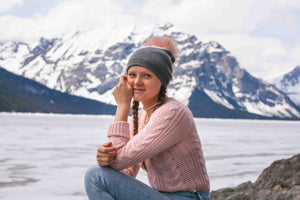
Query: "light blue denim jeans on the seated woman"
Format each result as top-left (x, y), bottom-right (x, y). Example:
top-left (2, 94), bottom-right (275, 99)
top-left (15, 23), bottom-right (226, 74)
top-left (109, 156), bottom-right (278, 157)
top-left (85, 165), bottom-right (209, 200)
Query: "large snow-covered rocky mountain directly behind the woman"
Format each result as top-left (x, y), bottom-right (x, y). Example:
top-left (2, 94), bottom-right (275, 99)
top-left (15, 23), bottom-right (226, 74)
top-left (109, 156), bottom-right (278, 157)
top-left (0, 24), bottom-right (300, 118)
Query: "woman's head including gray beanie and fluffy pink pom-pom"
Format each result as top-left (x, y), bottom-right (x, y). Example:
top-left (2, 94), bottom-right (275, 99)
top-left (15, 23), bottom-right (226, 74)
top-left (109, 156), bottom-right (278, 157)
top-left (127, 36), bottom-right (177, 106)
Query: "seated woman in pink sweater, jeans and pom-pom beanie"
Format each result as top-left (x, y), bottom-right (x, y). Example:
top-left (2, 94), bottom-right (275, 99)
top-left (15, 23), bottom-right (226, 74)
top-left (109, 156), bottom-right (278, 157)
top-left (85, 37), bottom-right (209, 200)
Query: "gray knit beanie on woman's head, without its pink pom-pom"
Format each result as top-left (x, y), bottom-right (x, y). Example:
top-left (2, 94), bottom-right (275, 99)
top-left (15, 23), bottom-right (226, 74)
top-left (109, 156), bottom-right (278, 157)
top-left (126, 46), bottom-right (175, 86)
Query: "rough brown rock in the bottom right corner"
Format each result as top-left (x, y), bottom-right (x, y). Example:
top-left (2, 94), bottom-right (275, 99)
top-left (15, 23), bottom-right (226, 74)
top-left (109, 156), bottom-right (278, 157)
top-left (210, 154), bottom-right (300, 200)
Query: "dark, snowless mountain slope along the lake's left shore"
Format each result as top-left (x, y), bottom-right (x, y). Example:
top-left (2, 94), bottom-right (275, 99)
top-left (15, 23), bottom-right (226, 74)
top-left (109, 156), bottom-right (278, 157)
top-left (0, 68), bottom-right (115, 114)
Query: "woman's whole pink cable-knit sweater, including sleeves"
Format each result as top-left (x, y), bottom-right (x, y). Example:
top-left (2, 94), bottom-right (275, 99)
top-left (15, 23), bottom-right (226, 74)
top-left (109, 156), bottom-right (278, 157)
top-left (108, 98), bottom-right (209, 192)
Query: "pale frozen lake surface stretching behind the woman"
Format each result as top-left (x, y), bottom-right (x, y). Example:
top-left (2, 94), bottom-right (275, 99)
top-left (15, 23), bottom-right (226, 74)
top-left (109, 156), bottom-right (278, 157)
top-left (0, 113), bottom-right (300, 200)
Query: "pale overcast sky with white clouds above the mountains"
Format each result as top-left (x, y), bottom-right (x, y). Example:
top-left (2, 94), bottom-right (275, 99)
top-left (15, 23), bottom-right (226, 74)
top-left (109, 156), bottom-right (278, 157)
top-left (0, 0), bottom-right (300, 80)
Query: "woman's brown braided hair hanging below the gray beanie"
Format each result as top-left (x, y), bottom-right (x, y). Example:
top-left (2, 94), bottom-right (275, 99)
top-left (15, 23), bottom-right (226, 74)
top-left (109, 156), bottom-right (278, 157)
top-left (132, 85), bottom-right (167, 171)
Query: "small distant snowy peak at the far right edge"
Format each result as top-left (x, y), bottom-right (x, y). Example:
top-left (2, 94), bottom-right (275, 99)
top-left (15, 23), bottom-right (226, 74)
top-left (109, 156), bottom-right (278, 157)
top-left (274, 66), bottom-right (300, 106)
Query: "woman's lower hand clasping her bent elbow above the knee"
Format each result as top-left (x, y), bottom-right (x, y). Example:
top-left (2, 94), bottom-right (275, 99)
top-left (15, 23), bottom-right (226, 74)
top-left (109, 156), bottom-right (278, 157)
top-left (97, 142), bottom-right (116, 167)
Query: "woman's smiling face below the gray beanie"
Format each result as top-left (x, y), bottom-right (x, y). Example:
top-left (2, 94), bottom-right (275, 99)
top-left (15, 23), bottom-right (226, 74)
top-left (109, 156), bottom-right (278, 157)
top-left (127, 66), bottom-right (161, 107)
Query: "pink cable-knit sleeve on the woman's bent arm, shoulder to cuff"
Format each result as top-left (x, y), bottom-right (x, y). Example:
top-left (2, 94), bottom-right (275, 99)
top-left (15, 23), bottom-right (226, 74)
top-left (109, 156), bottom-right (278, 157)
top-left (108, 104), bottom-right (193, 170)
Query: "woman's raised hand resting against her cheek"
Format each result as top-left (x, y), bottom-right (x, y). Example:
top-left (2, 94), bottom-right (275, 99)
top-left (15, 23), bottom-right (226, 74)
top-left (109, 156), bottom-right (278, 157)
top-left (113, 75), bottom-right (133, 106)
